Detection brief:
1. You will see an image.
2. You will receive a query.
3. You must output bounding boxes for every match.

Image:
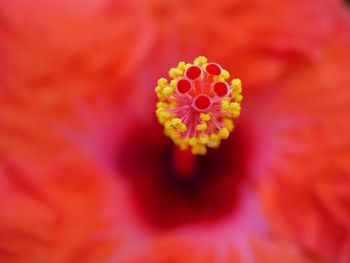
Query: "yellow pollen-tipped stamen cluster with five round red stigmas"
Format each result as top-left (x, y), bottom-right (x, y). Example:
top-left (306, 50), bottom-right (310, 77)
top-left (155, 56), bottom-right (243, 155)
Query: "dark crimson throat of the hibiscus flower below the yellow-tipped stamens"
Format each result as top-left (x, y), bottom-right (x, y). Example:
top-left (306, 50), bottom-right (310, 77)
top-left (117, 123), bottom-right (250, 231)
